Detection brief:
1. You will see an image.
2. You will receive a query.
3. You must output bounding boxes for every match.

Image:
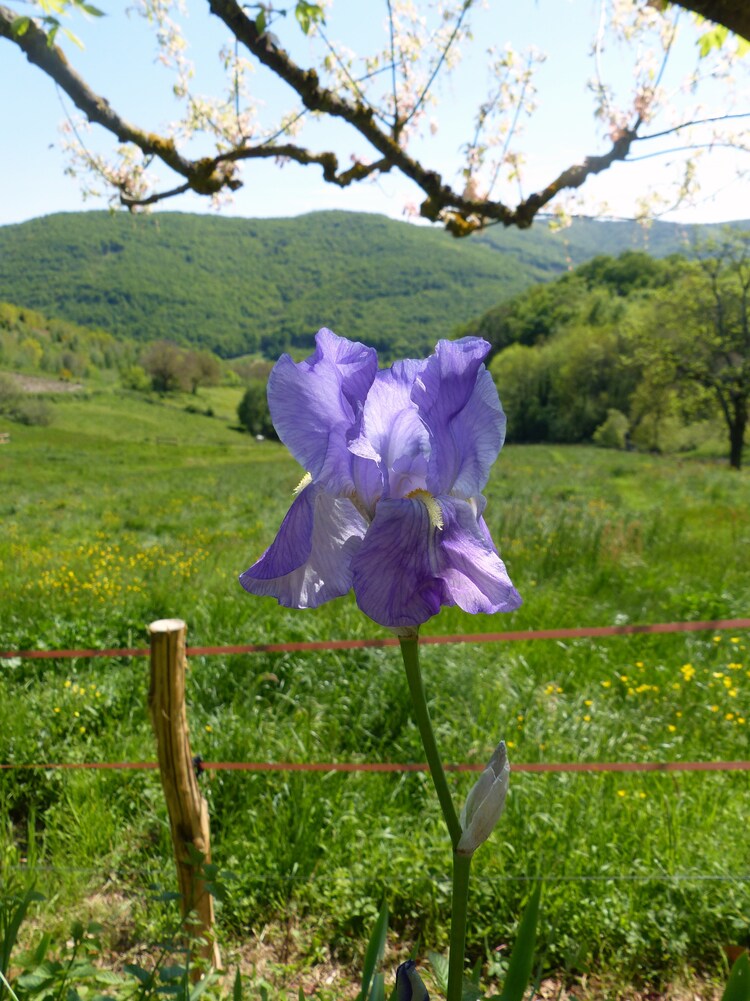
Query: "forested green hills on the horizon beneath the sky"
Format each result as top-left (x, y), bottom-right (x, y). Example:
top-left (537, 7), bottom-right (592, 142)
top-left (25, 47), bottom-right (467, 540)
top-left (0, 211), bottom-right (736, 356)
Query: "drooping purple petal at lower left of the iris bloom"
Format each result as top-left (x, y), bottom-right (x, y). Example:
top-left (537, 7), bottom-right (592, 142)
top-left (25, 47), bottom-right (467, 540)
top-left (239, 483), bottom-right (367, 609)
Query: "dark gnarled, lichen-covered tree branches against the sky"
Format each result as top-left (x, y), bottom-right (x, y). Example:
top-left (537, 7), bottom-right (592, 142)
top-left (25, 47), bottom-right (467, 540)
top-left (0, 0), bottom-right (736, 229)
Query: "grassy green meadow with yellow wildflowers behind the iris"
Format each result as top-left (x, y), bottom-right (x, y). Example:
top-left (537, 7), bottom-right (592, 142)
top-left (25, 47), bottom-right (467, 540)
top-left (0, 387), bottom-right (750, 996)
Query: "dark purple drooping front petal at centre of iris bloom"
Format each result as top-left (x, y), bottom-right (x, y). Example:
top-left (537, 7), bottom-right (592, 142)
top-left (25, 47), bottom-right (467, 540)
top-left (351, 497), bottom-right (444, 626)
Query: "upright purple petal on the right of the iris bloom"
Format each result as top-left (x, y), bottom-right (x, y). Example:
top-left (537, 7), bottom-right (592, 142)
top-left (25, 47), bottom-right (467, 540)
top-left (412, 337), bottom-right (506, 497)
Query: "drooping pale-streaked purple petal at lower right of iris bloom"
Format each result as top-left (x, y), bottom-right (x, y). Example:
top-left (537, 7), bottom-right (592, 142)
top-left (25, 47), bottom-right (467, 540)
top-left (438, 497), bottom-right (521, 614)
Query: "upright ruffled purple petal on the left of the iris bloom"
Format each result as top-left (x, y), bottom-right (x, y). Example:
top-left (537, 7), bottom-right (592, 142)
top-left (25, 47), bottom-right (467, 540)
top-left (268, 327), bottom-right (378, 493)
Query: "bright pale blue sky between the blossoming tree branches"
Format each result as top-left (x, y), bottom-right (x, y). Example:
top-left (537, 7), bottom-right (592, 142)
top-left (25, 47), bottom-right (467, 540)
top-left (0, 0), bottom-right (750, 224)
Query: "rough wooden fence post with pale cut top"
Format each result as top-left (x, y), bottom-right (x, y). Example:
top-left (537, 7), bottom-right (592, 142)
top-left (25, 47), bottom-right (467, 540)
top-left (148, 619), bottom-right (221, 968)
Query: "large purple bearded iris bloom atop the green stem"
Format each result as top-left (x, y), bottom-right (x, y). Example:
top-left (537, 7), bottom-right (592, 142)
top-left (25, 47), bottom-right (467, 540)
top-left (239, 327), bottom-right (521, 629)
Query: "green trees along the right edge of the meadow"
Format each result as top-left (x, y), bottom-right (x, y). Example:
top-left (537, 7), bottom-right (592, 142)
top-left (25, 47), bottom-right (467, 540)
top-left (461, 231), bottom-right (750, 468)
